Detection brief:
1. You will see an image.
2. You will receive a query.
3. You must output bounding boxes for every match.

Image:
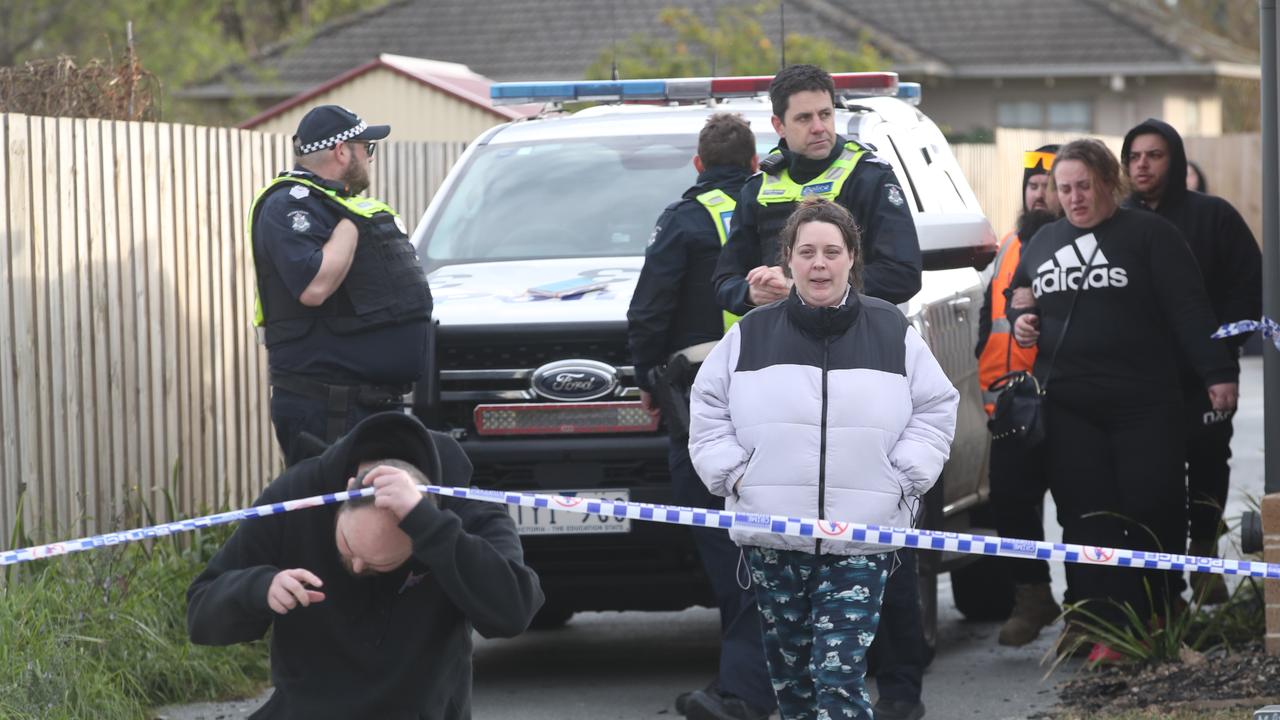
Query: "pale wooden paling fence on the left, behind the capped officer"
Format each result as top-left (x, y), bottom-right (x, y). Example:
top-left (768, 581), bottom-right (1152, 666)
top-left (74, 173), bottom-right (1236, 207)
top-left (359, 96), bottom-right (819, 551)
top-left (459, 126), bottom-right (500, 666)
top-left (0, 114), bottom-right (462, 547)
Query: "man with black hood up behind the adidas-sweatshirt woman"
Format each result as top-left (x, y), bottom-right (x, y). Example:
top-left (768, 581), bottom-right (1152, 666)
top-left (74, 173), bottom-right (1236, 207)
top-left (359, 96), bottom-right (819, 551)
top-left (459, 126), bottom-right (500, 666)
top-left (1120, 119), bottom-right (1262, 602)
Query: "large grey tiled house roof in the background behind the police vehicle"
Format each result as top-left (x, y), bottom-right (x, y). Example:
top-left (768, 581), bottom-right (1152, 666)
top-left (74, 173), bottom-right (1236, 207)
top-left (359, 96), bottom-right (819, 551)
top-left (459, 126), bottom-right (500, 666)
top-left (182, 0), bottom-right (1258, 99)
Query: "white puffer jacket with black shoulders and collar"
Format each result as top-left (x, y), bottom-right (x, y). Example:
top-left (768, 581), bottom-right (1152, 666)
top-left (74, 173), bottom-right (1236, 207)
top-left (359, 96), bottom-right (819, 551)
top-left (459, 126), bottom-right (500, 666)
top-left (689, 291), bottom-right (960, 555)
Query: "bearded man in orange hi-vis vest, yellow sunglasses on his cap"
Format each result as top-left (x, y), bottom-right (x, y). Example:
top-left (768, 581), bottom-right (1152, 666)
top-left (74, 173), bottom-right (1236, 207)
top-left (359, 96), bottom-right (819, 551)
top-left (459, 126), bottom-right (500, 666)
top-left (975, 145), bottom-right (1062, 647)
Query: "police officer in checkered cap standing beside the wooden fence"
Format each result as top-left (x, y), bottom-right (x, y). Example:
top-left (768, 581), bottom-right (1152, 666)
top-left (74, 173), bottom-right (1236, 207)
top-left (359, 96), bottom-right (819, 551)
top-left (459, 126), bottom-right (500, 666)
top-left (250, 105), bottom-right (431, 465)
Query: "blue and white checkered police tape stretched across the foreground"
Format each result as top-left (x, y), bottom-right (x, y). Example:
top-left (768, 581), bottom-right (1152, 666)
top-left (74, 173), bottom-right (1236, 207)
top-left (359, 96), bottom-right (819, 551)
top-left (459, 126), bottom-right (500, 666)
top-left (0, 486), bottom-right (1280, 579)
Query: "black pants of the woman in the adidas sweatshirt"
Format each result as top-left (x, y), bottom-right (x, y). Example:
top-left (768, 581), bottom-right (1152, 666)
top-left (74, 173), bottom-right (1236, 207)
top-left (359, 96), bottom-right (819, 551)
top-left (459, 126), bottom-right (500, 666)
top-left (1046, 393), bottom-right (1187, 623)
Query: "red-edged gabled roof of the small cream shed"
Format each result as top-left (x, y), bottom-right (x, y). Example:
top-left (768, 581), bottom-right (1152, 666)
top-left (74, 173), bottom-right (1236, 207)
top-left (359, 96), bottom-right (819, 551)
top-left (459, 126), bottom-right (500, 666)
top-left (239, 53), bottom-right (541, 128)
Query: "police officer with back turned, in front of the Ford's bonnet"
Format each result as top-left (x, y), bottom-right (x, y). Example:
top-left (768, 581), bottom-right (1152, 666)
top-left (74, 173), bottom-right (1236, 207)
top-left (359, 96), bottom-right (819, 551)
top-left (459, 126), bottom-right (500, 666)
top-left (627, 113), bottom-right (777, 720)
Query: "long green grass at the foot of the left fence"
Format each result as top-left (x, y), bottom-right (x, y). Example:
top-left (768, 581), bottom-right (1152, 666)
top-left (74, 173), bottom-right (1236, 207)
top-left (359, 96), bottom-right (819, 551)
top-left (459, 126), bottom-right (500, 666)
top-left (0, 486), bottom-right (269, 720)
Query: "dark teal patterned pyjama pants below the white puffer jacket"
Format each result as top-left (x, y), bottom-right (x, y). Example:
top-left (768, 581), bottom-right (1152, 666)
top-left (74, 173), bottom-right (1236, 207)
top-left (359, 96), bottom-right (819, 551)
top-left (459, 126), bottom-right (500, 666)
top-left (746, 547), bottom-right (893, 720)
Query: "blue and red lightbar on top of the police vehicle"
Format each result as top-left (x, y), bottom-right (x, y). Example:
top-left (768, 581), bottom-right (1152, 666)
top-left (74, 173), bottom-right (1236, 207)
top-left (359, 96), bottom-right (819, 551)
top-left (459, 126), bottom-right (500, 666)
top-left (489, 73), bottom-right (899, 105)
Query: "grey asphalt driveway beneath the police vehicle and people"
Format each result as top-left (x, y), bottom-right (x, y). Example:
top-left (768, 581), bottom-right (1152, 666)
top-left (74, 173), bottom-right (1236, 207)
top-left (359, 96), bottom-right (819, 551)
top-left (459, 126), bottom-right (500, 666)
top-left (156, 357), bottom-right (1263, 720)
